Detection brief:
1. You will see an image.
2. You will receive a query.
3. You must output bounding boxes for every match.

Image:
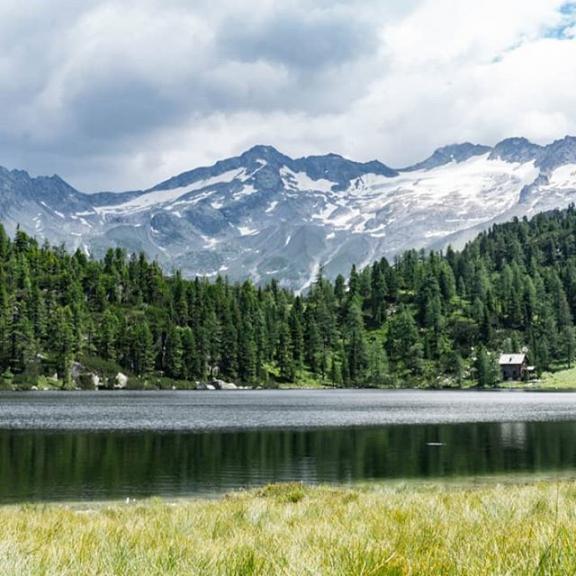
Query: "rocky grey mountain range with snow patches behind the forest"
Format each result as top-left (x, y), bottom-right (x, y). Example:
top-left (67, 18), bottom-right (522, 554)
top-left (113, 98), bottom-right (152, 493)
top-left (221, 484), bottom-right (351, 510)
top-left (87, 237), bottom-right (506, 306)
top-left (0, 137), bottom-right (576, 289)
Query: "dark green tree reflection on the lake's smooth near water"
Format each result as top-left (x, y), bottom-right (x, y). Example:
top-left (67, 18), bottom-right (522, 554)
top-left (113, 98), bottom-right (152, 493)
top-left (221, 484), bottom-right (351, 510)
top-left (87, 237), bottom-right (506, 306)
top-left (0, 422), bottom-right (576, 502)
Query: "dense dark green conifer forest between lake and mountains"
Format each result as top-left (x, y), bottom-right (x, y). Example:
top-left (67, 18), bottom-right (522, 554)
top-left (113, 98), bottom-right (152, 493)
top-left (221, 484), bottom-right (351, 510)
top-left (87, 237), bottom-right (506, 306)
top-left (0, 207), bottom-right (576, 387)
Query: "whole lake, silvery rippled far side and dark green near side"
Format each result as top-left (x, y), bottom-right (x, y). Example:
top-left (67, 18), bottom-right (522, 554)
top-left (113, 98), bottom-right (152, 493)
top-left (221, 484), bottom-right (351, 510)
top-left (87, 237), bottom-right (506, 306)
top-left (0, 391), bottom-right (576, 503)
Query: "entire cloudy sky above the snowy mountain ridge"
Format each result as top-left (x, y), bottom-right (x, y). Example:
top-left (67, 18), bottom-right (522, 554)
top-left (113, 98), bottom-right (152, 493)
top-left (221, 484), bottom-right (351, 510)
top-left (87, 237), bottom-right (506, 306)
top-left (0, 0), bottom-right (576, 192)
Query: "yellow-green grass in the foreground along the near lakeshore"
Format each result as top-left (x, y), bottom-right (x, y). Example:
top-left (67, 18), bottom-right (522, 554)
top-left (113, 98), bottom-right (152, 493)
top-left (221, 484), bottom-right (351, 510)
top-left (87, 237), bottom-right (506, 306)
top-left (0, 482), bottom-right (576, 576)
